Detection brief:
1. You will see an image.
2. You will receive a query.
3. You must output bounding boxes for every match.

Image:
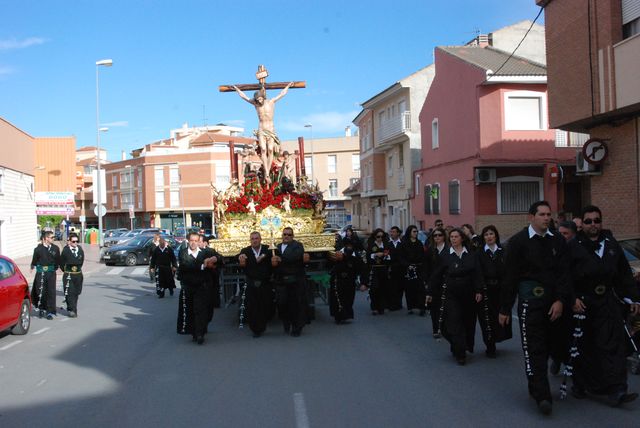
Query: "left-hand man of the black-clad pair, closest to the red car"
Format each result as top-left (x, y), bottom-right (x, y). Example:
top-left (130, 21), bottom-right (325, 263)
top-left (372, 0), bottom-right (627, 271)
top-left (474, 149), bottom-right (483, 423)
top-left (31, 232), bottom-right (60, 320)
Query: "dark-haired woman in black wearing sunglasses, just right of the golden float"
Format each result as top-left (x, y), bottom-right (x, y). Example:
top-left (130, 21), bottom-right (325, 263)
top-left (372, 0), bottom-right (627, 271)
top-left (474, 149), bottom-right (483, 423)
top-left (366, 229), bottom-right (391, 315)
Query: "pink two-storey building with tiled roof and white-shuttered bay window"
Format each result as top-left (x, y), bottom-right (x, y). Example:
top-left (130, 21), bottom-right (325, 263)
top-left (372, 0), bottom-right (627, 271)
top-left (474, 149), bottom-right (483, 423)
top-left (412, 43), bottom-right (588, 237)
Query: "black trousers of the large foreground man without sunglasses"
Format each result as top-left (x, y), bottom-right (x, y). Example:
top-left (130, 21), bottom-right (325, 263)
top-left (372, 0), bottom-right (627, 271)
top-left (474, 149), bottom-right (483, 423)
top-left (518, 299), bottom-right (568, 402)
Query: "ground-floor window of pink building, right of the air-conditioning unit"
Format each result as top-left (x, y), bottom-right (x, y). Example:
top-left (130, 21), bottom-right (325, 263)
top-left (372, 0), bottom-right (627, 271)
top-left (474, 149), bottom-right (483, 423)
top-left (496, 177), bottom-right (544, 214)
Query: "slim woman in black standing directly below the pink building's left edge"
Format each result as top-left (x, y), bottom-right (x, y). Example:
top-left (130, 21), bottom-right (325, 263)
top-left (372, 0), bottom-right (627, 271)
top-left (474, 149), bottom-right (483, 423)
top-left (399, 225), bottom-right (426, 317)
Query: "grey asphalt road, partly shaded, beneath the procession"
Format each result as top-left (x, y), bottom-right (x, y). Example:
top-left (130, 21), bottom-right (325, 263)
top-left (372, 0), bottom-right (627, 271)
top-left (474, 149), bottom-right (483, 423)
top-left (0, 267), bottom-right (640, 428)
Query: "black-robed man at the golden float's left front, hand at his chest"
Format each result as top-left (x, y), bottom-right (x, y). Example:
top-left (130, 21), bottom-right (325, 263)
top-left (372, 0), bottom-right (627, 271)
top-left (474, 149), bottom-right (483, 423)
top-left (178, 233), bottom-right (218, 345)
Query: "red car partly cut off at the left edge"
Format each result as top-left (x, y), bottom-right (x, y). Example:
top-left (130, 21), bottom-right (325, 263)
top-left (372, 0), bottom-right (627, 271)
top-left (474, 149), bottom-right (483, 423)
top-left (0, 256), bottom-right (31, 334)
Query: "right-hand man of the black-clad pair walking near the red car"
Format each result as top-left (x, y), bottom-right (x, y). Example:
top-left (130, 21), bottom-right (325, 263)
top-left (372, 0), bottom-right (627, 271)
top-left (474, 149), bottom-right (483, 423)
top-left (61, 233), bottom-right (84, 318)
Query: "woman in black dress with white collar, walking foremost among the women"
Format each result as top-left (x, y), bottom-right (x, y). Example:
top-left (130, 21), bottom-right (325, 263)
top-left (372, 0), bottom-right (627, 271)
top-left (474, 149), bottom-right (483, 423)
top-left (427, 228), bottom-right (484, 365)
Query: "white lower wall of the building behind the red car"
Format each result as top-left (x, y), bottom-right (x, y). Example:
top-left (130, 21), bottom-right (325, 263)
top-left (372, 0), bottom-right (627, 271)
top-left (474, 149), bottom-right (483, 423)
top-left (0, 167), bottom-right (38, 259)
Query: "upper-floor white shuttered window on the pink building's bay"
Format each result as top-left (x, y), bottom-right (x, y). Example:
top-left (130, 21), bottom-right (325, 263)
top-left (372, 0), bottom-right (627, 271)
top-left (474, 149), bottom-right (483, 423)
top-left (504, 91), bottom-right (547, 130)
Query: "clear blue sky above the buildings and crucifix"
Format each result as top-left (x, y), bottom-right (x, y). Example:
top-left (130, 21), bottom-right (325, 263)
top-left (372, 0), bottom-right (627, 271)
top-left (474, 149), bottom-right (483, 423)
top-left (0, 0), bottom-right (538, 160)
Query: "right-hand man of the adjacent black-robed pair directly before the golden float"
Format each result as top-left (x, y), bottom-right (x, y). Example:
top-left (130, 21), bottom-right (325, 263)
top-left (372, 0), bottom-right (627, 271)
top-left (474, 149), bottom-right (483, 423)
top-left (272, 227), bottom-right (307, 337)
